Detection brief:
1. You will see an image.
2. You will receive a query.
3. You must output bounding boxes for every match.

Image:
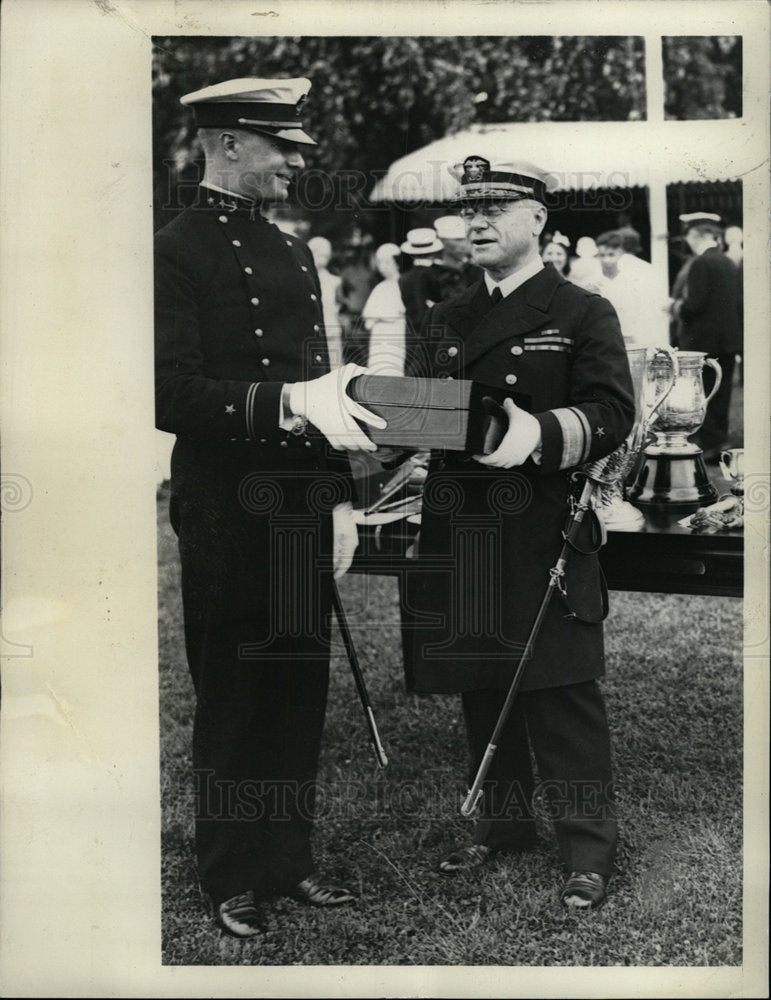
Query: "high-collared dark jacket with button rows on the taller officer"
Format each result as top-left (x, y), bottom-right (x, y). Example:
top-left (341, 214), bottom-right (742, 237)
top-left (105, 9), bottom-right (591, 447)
top-left (155, 188), bottom-right (340, 495)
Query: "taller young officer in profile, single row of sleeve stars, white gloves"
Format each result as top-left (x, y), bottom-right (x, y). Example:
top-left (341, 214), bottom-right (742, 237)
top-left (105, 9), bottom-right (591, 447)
top-left (155, 79), bottom-right (379, 937)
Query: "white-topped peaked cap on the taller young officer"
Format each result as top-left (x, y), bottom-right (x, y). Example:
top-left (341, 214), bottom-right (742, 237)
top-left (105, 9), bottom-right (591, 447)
top-left (180, 77), bottom-right (316, 146)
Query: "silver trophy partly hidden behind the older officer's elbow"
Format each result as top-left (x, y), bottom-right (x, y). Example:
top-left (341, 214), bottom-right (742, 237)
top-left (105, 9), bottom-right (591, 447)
top-left (592, 347), bottom-right (678, 531)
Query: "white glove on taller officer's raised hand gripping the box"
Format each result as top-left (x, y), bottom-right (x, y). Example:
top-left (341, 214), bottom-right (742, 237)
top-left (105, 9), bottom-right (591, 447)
top-left (289, 364), bottom-right (386, 451)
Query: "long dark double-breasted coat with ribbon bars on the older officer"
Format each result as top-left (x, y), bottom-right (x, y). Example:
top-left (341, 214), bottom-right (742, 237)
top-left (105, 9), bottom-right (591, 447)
top-left (406, 268), bottom-right (634, 693)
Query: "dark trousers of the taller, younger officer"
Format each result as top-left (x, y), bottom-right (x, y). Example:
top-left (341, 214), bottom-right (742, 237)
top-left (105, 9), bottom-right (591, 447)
top-left (171, 482), bottom-right (331, 901)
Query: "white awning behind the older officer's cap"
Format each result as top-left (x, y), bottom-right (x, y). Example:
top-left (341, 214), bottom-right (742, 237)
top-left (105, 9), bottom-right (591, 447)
top-left (370, 120), bottom-right (760, 203)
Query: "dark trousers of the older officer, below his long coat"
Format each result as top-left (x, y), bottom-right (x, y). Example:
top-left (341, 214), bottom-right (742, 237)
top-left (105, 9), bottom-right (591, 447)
top-left (462, 680), bottom-right (617, 876)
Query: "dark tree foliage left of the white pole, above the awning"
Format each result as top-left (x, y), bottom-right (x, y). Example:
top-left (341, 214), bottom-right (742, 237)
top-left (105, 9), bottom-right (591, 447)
top-left (153, 36), bottom-right (645, 234)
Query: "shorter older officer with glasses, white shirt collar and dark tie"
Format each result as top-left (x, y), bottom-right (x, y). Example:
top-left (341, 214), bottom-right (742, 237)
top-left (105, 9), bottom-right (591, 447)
top-left (407, 156), bottom-right (634, 908)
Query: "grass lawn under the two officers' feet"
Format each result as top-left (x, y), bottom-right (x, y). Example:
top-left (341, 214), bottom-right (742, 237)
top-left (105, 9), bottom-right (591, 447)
top-left (158, 480), bottom-right (742, 966)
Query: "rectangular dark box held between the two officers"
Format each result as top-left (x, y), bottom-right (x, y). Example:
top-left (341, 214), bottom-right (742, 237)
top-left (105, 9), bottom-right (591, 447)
top-left (348, 375), bottom-right (530, 455)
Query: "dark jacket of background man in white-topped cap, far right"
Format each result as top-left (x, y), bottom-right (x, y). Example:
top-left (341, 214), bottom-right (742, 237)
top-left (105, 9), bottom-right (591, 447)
top-left (679, 247), bottom-right (742, 358)
